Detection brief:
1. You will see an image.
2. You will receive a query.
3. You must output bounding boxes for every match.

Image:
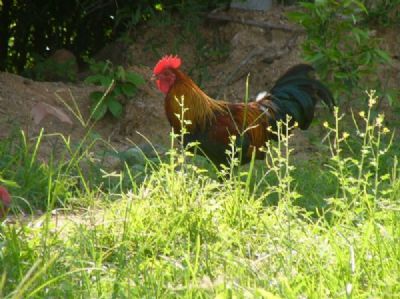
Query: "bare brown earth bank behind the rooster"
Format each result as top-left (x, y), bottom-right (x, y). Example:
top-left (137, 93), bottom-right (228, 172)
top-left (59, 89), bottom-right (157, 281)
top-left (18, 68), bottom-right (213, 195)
top-left (0, 7), bottom-right (400, 165)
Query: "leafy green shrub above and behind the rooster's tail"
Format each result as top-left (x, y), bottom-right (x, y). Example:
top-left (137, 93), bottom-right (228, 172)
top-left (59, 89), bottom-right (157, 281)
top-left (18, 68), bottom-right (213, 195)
top-left (289, 0), bottom-right (390, 102)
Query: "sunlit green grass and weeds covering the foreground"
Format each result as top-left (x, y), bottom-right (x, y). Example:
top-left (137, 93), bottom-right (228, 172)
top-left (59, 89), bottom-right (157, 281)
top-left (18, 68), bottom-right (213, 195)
top-left (0, 95), bottom-right (400, 298)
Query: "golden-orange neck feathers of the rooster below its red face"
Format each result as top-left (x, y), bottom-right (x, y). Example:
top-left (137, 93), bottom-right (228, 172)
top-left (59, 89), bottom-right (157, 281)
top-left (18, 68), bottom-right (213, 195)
top-left (165, 70), bottom-right (227, 132)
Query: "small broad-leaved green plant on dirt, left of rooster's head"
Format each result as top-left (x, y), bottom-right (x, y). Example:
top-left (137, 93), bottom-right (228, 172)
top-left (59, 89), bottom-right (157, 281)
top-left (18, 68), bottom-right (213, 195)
top-left (85, 60), bottom-right (144, 120)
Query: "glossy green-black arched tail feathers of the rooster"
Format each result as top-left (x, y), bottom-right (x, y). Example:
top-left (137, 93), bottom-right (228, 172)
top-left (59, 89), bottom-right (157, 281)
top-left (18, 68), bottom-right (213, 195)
top-left (267, 64), bottom-right (335, 130)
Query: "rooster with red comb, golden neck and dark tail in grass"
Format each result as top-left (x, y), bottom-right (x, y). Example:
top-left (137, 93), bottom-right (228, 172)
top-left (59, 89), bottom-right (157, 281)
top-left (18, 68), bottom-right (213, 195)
top-left (153, 55), bottom-right (334, 166)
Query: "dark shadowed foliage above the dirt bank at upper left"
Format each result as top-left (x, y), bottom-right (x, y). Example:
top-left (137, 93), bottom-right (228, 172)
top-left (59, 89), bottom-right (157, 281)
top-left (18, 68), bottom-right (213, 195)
top-left (0, 0), bottom-right (227, 73)
